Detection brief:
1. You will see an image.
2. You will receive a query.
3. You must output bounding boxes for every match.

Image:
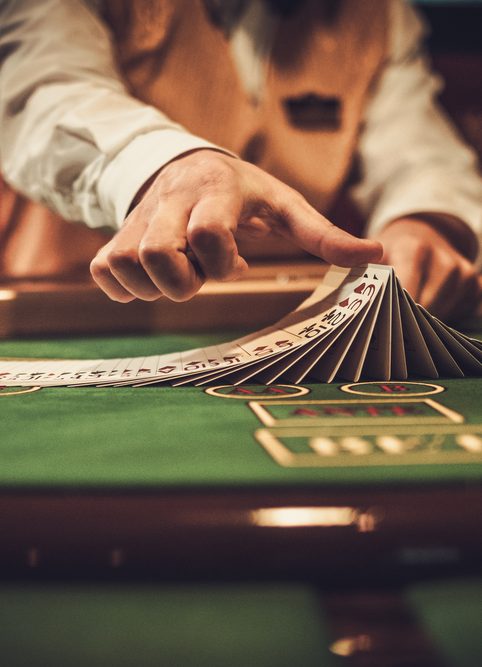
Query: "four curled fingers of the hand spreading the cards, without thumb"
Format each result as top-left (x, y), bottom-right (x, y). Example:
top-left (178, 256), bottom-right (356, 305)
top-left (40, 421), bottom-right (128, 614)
top-left (91, 197), bottom-right (247, 303)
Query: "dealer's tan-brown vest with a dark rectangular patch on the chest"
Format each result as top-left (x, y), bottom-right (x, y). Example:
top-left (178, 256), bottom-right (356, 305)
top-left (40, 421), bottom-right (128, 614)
top-left (0, 0), bottom-right (387, 280)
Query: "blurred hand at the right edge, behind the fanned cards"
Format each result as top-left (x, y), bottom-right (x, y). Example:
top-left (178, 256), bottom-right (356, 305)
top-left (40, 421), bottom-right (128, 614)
top-left (378, 218), bottom-right (480, 319)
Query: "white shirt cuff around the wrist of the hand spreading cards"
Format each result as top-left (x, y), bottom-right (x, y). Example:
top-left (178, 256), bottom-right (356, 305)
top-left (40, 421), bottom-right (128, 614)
top-left (98, 129), bottom-right (237, 229)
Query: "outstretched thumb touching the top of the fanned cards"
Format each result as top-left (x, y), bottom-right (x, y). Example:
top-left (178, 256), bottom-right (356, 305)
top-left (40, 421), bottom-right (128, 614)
top-left (274, 195), bottom-right (383, 266)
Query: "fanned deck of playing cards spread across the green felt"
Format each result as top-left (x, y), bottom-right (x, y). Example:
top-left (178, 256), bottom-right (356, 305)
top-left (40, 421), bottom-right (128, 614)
top-left (0, 264), bottom-right (482, 387)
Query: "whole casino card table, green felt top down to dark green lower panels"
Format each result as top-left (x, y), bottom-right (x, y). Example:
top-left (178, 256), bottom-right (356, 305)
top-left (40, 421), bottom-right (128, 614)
top-left (0, 268), bottom-right (482, 667)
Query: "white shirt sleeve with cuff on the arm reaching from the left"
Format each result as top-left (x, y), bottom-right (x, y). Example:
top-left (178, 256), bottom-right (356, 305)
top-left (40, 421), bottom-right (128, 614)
top-left (0, 0), bottom-right (228, 228)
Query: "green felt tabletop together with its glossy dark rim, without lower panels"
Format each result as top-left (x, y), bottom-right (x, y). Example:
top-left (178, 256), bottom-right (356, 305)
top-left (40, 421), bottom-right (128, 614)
top-left (0, 322), bottom-right (482, 580)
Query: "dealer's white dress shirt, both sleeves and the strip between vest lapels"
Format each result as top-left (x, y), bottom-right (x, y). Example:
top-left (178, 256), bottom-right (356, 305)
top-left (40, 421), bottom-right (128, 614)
top-left (0, 0), bottom-right (482, 258)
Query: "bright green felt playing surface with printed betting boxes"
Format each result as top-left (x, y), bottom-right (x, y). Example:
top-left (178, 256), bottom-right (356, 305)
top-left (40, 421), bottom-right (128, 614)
top-left (0, 333), bottom-right (482, 488)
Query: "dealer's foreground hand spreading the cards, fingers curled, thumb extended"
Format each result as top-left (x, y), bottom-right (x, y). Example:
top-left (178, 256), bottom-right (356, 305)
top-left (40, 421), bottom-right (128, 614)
top-left (91, 149), bottom-right (382, 303)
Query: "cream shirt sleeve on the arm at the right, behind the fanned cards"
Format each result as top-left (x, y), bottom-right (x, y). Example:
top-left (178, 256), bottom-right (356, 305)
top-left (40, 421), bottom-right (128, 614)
top-left (351, 0), bottom-right (482, 254)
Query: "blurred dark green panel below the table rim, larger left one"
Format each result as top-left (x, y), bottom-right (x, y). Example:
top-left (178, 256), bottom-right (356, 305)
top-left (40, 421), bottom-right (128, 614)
top-left (0, 583), bottom-right (338, 667)
